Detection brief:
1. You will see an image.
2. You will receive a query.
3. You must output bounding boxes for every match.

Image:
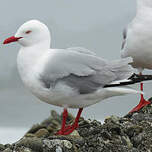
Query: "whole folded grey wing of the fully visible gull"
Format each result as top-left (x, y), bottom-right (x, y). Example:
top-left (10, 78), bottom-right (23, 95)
top-left (40, 51), bottom-right (131, 94)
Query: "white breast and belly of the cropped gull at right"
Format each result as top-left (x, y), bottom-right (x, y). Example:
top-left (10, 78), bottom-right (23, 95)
top-left (122, 14), bottom-right (152, 69)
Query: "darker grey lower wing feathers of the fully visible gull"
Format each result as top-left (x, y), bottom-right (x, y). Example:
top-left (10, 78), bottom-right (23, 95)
top-left (56, 68), bottom-right (117, 94)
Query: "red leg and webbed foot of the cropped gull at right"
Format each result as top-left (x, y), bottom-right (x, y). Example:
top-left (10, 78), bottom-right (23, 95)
top-left (130, 73), bottom-right (151, 113)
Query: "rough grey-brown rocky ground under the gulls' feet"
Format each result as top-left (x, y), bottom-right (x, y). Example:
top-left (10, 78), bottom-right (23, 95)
top-left (0, 100), bottom-right (152, 152)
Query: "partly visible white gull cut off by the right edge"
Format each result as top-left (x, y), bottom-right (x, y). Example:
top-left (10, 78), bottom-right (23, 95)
top-left (121, 0), bottom-right (152, 112)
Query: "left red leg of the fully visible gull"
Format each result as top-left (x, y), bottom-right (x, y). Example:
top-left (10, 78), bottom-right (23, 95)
top-left (57, 108), bottom-right (68, 135)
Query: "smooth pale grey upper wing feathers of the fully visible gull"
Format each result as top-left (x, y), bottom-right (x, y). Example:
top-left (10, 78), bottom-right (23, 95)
top-left (41, 50), bottom-right (107, 81)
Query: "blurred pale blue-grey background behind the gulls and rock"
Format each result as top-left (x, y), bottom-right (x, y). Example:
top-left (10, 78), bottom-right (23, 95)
top-left (0, 0), bottom-right (152, 143)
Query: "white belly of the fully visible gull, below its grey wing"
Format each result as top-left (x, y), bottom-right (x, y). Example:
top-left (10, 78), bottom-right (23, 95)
top-left (28, 81), bottom-right (109, 108)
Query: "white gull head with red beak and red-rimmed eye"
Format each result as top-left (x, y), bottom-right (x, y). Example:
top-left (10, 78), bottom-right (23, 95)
top-left (4, 20), bottom-right (51, 47)
